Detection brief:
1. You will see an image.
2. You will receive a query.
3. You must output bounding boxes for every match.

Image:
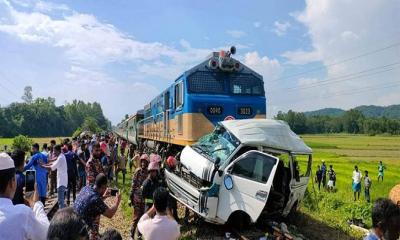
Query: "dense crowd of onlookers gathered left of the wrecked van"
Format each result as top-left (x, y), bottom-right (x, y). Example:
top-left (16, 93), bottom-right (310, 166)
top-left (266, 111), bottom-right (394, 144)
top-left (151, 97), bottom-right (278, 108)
top-left (0, 133), bottom-right (180, 240)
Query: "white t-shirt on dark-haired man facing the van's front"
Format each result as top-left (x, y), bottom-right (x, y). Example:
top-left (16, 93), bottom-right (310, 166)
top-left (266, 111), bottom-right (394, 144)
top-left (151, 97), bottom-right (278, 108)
top-left (138, 213), bottom-right (180, 240)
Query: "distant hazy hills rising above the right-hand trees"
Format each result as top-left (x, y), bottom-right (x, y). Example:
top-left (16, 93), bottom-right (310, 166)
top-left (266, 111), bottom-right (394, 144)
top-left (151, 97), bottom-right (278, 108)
top-left (304, 104), bottom-right (400, 119)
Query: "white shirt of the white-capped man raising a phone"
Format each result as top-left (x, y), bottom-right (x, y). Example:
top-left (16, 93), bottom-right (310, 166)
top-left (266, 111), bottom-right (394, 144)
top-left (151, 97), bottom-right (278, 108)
top-left (0, 198), bottom-right (50, 240)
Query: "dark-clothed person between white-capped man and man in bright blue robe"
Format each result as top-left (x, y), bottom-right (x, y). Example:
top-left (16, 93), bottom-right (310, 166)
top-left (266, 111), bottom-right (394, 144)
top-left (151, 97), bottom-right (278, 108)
top-left (11, 150), bottom-right (25, 205)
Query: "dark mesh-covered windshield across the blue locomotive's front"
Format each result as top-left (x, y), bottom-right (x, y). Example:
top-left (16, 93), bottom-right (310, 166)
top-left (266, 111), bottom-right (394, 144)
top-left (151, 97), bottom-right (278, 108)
top-left (188, 71), bottom-right (264, 96)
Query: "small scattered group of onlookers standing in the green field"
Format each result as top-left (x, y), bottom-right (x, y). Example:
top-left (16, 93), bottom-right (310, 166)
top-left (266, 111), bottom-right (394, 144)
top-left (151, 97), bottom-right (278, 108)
top-left (315, 160), bottom-right (386, 202)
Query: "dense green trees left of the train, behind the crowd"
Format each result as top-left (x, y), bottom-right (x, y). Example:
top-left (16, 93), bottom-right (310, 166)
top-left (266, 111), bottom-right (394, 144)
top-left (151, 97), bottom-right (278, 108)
top-left (0, 95), bottom-right (111, 137)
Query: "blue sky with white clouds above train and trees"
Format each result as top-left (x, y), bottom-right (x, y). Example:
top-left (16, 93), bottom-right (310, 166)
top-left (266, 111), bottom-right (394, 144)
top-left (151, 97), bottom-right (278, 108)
top-left (0, 0), bottom-right (400, 124)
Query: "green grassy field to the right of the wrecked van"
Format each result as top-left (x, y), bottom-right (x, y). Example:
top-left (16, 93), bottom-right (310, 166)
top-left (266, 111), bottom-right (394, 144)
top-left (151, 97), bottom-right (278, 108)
top-left (301, 134), bottom-right (400, 237)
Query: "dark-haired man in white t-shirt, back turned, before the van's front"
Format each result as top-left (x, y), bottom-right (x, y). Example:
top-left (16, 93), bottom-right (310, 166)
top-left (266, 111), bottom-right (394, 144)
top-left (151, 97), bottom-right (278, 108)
top-left (138, 187), bottom-right (180, 240)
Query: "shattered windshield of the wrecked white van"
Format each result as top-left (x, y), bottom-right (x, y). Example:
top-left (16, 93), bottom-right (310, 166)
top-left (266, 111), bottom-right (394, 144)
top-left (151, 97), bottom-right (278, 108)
top-left (192, 126), bottom-right (240, 165)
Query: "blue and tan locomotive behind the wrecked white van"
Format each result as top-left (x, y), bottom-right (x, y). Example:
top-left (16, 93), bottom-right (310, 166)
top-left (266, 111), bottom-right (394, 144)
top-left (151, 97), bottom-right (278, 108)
top-left (115, 47), bottom-right (266, 151)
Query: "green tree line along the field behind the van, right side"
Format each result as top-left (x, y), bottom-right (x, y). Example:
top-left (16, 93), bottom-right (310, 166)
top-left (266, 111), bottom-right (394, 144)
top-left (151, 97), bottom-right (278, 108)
top-left (275, 109), bottom-right (400, 135)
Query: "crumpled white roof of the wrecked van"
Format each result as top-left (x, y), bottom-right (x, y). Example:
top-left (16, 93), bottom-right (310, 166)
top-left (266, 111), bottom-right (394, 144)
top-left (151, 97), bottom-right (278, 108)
top-left (220, 119), bottom-right (312, 154)
